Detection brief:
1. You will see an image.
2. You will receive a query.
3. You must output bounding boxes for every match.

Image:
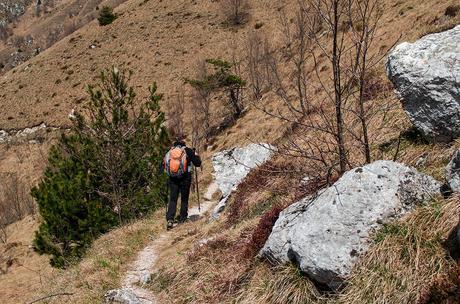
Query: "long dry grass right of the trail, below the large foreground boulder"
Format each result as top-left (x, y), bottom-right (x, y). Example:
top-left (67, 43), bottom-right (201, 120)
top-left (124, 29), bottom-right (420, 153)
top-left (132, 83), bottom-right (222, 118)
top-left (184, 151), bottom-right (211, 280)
top-left (152, 192), bottom-right (460, 304)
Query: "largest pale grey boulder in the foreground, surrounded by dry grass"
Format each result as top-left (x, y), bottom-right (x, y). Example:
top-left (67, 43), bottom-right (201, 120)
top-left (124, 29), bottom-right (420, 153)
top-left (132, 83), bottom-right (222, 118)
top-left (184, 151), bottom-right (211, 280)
top-left (260, 161), bottom-right (440, 289)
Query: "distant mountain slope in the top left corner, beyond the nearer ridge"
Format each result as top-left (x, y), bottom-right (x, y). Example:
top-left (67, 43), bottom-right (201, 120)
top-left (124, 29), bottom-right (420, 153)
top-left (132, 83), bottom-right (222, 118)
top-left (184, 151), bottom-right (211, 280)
top-left (0, 0), bottom-right (128, 75)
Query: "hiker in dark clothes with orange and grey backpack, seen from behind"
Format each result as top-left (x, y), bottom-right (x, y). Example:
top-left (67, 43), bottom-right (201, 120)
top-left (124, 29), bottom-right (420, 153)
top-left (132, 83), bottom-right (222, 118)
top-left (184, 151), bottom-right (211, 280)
top-left (162, 138), bottom-right (201, 230)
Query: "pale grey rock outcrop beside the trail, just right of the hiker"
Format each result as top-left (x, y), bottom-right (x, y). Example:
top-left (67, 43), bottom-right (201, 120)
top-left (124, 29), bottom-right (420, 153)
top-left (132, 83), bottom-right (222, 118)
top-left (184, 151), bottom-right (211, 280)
top-left (212, 144), bottom-right (275, 218)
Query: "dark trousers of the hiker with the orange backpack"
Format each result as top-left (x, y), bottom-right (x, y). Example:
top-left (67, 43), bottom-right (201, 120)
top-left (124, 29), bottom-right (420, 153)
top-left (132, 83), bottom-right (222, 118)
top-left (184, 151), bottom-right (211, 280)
top-left (166, 175), bottom-right (192, 221)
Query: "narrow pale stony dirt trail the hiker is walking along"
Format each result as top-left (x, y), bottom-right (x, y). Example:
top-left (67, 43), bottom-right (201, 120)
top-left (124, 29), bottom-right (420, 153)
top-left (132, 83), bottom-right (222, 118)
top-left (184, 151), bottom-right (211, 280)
top-left (122, 182), bottom-right (218, 304)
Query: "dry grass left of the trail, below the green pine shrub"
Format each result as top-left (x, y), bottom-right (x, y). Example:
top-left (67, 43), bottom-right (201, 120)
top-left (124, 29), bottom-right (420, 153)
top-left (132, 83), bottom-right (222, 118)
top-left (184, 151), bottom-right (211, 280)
top-left (0, 210), bottom-right (164, 303)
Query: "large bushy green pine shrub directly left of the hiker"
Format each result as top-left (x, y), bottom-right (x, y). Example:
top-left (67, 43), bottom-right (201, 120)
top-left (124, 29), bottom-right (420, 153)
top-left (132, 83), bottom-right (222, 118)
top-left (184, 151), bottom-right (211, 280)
top-left (32, 69), bottom-right (168, 267)
